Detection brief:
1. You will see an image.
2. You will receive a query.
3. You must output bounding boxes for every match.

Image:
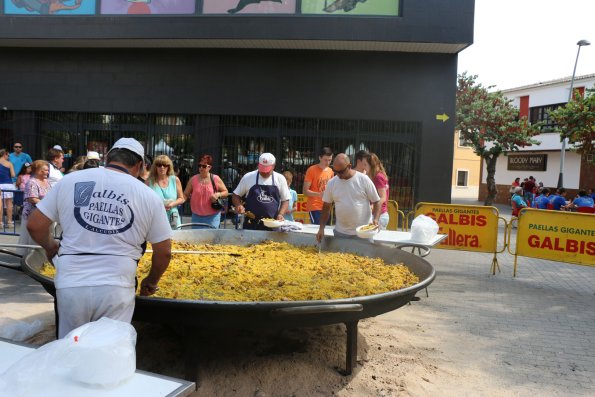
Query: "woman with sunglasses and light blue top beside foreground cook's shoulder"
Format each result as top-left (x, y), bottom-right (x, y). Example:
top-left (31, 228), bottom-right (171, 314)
top-left (147, 154), bottom-right (186, 229)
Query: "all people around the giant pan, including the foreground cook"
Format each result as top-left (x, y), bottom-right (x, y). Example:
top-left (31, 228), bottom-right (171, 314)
top-left (0, 138), bottom-right (396, 338)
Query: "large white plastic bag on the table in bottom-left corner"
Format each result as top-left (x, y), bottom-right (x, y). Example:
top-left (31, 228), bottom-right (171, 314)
top-left (0, 317), bottom-right (136, 397)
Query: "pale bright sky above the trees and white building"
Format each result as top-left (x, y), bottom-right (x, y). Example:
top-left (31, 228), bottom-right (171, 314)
top-left (458, 0), bottom-right (595, 90)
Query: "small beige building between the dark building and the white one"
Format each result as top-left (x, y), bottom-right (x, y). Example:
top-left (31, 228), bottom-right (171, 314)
top-left (451, 131), bottom-right (481, 199)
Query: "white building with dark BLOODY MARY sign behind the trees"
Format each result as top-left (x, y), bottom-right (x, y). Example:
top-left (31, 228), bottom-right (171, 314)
top-left (480, 74), bottom-right (595, 203)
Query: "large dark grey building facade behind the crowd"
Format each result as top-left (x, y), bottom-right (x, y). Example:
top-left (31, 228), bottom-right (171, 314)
top-left (0, 0), bottom-right (474, 208)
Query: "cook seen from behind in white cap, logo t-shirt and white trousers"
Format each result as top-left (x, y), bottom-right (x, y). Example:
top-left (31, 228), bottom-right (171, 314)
top-left (27, 138), bottom-right (171, 338)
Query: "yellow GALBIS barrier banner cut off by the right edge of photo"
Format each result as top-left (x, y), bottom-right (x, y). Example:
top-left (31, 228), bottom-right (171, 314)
top-left (516, 209), bottom-right (595, 266)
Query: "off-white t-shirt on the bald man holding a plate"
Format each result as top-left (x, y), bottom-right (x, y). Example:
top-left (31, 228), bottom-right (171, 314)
top-left (322, 172), bottom-right (380, 235)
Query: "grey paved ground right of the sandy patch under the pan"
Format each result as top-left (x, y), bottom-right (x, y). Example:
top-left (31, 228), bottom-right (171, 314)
top-left (379, 236), bottom-right (595, 396)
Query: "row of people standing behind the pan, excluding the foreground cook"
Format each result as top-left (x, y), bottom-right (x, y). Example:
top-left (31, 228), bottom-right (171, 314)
top-left (0, 142), bottom-right (396, 237)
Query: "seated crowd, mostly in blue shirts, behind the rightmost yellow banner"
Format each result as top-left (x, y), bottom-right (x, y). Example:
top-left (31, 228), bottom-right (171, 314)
top-left (510, 176), bottom-right (595, 216)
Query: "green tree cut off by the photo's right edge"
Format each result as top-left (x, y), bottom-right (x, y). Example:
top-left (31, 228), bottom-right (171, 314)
top-left (550, 90), bottom-right (595, 162)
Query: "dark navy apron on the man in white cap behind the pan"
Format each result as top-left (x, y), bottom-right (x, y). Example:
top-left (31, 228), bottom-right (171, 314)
top-left (244, 172), bottom-right (281, 230)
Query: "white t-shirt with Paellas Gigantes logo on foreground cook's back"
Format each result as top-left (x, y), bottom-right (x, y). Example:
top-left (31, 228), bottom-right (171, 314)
top-left (37, 168), bottom-right (172, 288)
